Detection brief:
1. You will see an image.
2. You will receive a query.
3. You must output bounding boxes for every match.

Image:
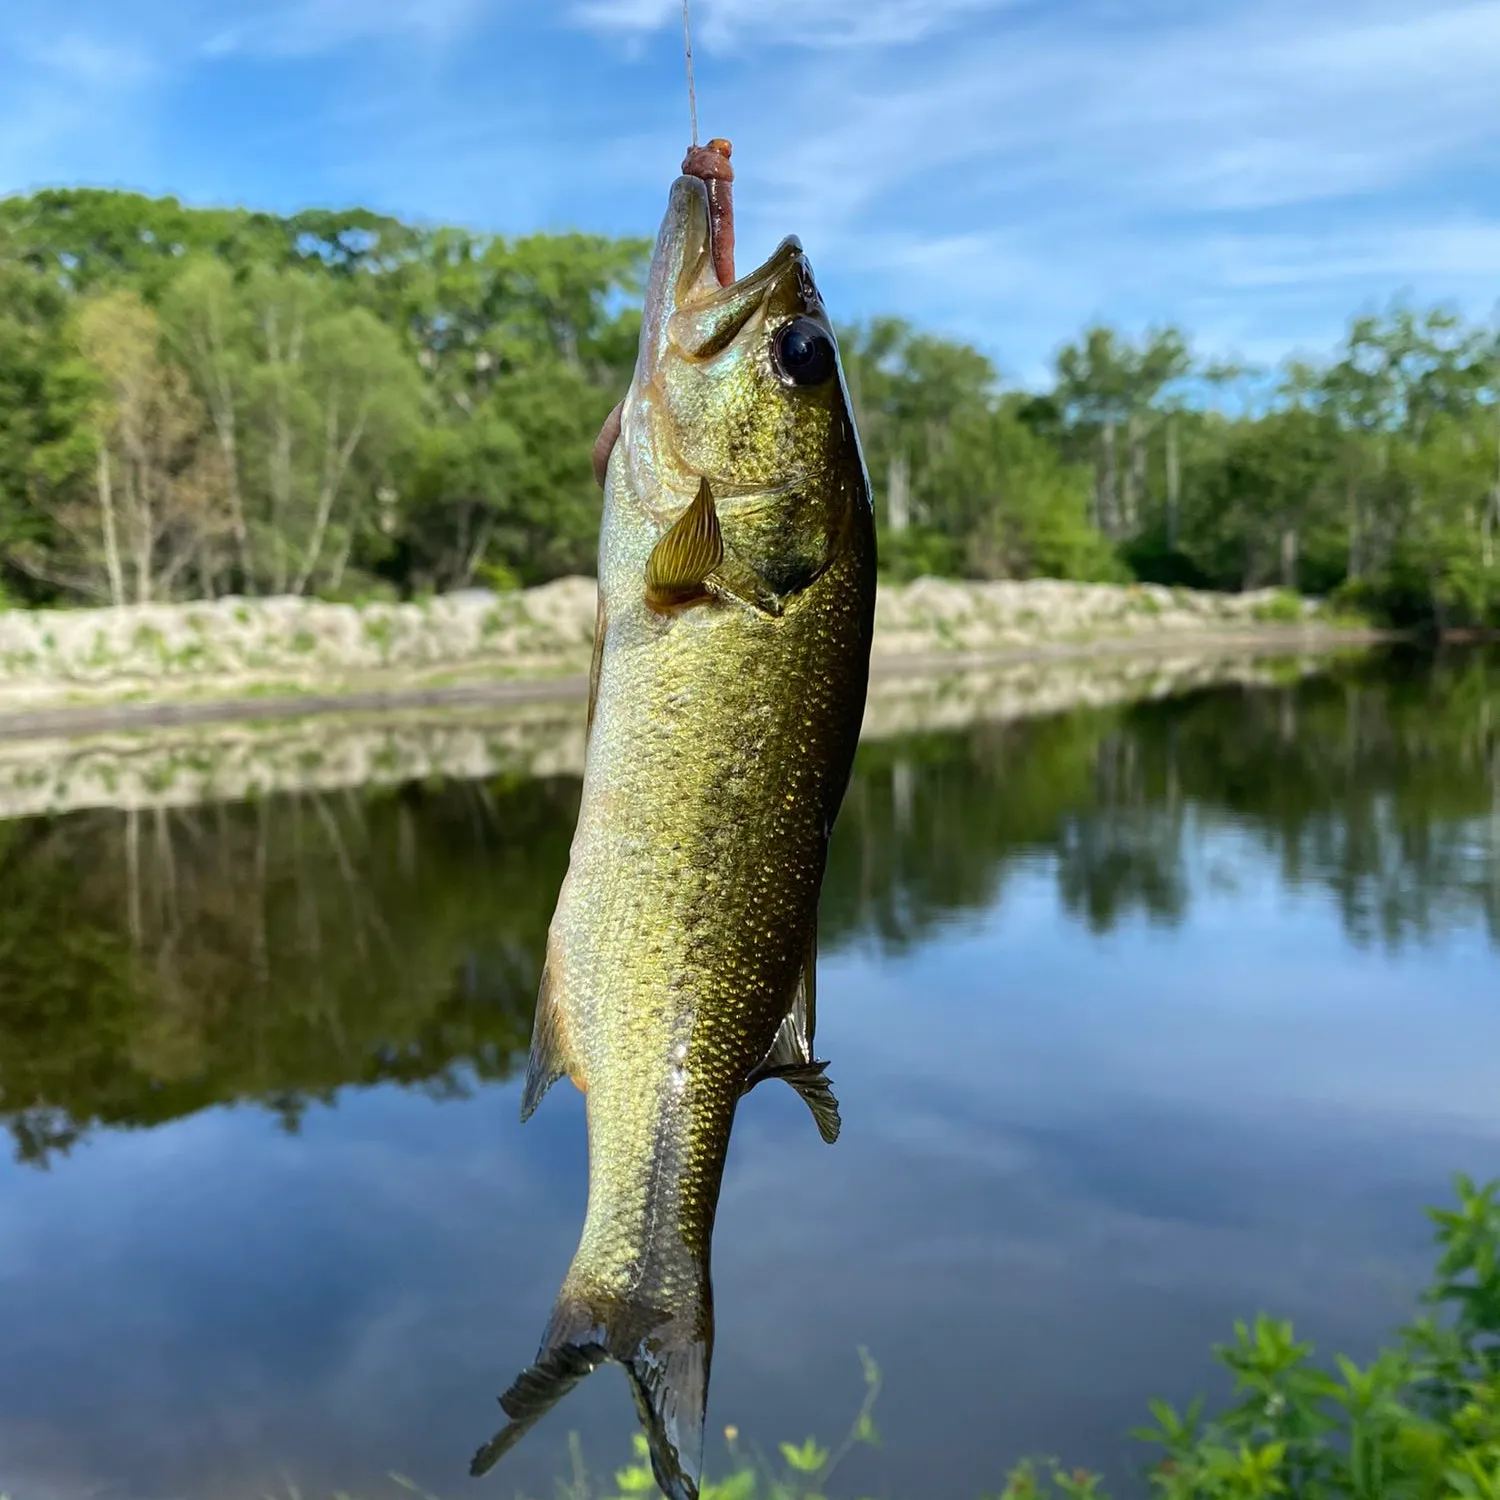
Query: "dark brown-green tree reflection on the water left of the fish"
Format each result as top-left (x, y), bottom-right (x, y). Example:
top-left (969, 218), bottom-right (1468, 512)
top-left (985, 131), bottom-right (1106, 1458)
top-left (0, 780), bottom-right (578, 1164)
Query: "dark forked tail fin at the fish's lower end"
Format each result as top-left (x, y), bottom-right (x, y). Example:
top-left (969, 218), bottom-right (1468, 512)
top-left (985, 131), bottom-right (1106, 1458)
top-left (470, 1274), bottom-right (713, 1500)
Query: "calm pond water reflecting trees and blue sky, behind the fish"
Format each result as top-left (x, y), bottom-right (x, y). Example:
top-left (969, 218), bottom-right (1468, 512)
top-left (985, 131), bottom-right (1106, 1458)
top-left (0, 654), bottom-right (1500, 1500)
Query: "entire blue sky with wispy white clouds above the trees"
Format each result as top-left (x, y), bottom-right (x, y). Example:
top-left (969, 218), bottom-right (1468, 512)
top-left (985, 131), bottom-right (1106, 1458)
top-left (0, 0), bottom-right (1500, 381)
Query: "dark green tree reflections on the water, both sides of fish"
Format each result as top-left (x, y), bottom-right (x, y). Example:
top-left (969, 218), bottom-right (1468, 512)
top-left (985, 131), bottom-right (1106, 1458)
top-left (0, 651), bottom-right (1500, 1166)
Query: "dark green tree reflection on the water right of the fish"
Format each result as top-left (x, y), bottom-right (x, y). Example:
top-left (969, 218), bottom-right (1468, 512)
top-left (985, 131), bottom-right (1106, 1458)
top-left (824, 653), bottom-right (1500, 950)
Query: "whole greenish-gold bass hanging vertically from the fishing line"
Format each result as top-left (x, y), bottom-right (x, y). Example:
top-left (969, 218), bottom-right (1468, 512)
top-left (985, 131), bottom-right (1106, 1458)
top-left (471, 143), bottom-right (876, 1500)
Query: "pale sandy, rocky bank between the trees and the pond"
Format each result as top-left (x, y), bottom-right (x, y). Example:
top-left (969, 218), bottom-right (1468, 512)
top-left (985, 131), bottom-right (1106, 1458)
top-left (0, 578), bottom-right (1371, 719)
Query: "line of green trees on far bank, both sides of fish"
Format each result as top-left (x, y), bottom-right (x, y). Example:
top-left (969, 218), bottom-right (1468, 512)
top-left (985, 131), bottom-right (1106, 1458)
top-left (0, 189), bottom-right (1500, 627)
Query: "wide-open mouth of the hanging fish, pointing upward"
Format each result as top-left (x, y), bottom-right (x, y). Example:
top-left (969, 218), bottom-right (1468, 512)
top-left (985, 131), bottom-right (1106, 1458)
top-left (639, 176), bottom-right (822, 381)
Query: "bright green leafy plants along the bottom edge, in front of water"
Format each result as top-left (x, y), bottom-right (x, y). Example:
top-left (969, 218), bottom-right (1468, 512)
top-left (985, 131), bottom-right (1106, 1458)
top-left (519, 1176), bottom-right (1500, 1500)
